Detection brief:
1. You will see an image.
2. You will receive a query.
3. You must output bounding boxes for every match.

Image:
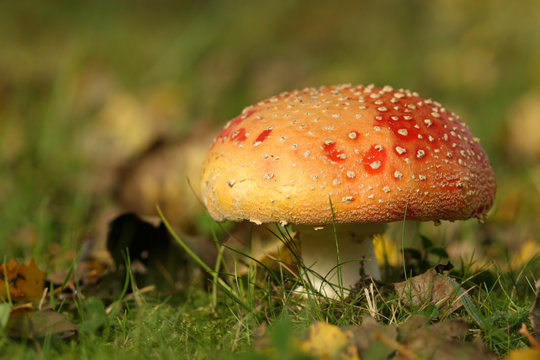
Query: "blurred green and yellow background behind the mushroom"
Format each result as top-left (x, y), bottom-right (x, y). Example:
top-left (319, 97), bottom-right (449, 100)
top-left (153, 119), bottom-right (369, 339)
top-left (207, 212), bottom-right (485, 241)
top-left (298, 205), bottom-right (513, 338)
top-left (0, 0), bottom-right (540, 260)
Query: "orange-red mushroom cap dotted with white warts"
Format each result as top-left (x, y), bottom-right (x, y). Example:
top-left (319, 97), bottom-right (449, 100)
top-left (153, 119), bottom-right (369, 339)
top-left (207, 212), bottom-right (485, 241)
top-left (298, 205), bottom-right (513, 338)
top-left (201, 85), bottom-right (496, 225)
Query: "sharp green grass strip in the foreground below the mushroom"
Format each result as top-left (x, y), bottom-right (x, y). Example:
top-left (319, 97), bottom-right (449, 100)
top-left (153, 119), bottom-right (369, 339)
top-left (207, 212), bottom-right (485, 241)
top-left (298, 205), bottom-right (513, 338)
top-left (0, 219), bottom-right (538, 359)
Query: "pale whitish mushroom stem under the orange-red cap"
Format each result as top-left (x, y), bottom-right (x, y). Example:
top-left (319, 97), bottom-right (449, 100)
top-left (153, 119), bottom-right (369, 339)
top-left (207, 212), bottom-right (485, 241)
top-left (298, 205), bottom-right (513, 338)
top-left (295, 223), bottom-right (386, 298)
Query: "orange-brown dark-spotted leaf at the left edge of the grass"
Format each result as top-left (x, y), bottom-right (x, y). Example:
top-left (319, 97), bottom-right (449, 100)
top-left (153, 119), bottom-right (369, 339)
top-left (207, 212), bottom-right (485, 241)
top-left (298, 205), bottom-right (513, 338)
top-left (0, 259), bottom-right (47, 301)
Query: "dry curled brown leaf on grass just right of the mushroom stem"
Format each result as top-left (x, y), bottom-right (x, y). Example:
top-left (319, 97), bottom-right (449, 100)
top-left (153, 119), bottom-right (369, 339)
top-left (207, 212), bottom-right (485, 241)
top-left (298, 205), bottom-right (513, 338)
top-left (394, 269), bottom-right (463, 312)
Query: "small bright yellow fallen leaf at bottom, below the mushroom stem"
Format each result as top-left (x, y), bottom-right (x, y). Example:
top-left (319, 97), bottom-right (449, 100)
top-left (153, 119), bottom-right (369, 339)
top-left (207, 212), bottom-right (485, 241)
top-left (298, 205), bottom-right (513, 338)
top-left (300, 322), bottom-right (360, 360)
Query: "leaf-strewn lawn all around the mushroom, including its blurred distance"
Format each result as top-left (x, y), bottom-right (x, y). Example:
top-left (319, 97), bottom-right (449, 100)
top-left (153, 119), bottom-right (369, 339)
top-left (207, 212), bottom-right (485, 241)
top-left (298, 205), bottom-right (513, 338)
top-left (0, 0), bottom-right (540, 359)
